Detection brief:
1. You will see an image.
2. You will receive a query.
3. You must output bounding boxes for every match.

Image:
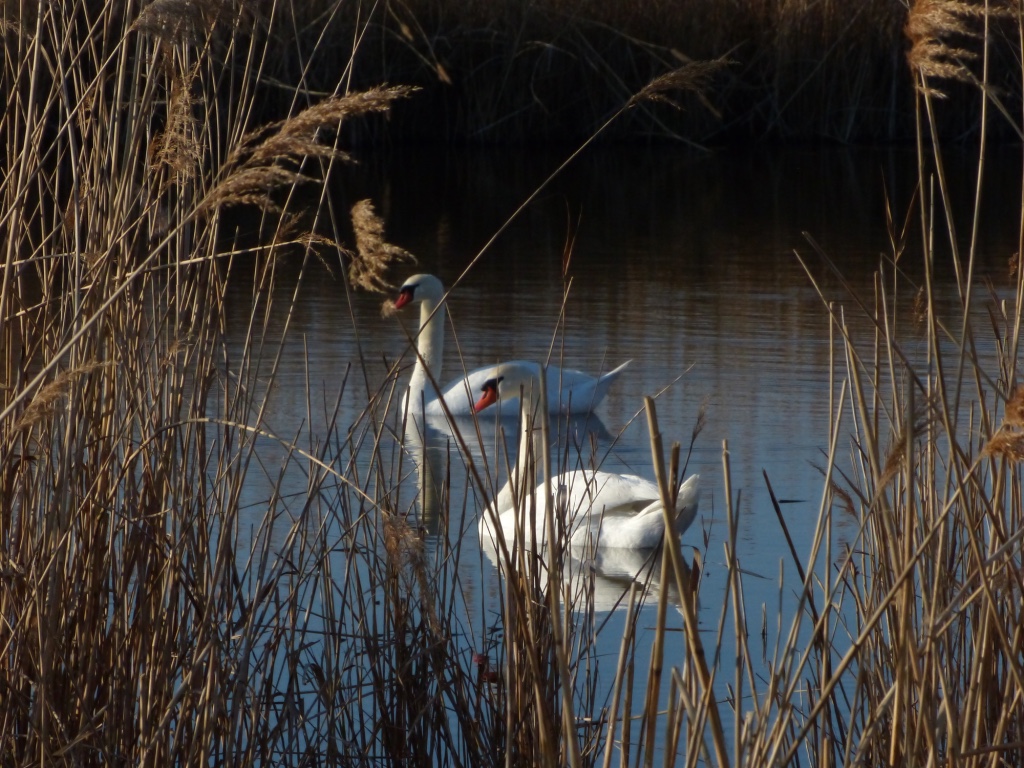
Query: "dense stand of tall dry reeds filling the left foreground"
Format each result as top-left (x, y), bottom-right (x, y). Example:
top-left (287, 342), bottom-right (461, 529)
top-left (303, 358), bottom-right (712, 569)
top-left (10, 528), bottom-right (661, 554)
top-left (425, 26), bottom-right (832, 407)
top-left (0, 3), bottom-right (487, 765)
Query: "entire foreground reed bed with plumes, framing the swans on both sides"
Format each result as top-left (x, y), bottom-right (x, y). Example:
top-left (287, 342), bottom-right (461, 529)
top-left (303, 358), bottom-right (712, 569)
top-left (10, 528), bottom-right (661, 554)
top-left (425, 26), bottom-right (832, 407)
top-left (6, 0), bottom-right (1024, 766)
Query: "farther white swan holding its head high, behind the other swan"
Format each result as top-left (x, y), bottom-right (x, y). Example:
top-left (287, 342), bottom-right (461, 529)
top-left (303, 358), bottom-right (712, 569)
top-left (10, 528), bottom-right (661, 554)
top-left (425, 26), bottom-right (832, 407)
top-left (394, 274), bottom-right (630, 416)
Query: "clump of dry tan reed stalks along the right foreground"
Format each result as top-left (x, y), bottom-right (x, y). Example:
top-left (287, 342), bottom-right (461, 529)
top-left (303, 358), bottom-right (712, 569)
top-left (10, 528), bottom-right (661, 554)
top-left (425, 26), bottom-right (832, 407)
top-left (786, 151), bottom-right (1021, 762)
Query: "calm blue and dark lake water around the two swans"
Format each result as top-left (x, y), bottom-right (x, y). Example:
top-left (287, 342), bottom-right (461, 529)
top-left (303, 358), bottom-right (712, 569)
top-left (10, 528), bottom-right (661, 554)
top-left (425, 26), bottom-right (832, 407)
top-left (222, 148), bottom-right (1020, 765)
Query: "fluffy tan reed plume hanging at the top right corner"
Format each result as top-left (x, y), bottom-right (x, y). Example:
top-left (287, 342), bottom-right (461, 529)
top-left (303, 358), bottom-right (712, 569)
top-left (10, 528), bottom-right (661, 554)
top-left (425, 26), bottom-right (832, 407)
top-left (904, 0), bottom-right (984, 91)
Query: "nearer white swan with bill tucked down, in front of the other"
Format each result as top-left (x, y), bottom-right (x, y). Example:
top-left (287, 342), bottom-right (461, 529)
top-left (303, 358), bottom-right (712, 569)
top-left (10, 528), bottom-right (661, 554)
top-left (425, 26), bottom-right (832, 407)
top-left (475, 362), bottom-right (700, 549)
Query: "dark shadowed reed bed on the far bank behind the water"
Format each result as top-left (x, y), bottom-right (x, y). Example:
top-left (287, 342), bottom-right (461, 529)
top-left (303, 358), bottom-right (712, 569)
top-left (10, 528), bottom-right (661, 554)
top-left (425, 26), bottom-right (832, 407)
top-left (66, 0), bottom-right (1021, 146)
